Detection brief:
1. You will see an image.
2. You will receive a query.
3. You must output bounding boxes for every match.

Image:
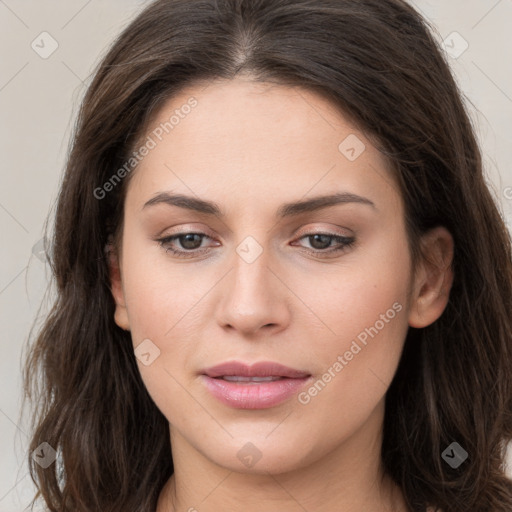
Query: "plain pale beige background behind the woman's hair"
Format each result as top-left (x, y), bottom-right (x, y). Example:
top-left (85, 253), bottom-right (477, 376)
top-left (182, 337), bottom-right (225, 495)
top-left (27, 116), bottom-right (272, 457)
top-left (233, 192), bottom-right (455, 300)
top-left (0, 0), bottom-right (512, 512)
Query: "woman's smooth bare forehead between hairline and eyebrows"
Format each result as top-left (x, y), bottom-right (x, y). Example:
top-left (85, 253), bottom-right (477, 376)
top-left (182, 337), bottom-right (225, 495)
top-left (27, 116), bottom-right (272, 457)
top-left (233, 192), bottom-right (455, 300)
top-left (127, 79), bottom-right (399, 216)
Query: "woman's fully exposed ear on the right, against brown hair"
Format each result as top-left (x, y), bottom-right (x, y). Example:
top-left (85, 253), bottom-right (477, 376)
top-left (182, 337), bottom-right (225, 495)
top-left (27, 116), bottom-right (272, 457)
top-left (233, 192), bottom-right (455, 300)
top-left (409, 226), bottom-right (453, 327)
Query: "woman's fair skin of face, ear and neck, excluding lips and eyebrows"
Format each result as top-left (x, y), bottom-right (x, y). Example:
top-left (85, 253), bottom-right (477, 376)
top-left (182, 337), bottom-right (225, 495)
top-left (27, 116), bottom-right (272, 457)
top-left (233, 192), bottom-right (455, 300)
top-left (110, 78), bottom-right (453, 512)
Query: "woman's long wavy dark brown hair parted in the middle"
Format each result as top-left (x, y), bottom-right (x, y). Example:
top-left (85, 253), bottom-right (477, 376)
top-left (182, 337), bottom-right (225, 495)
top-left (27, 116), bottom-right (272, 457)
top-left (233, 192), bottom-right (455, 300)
top-left (20, 0), bottom-right (512, 512)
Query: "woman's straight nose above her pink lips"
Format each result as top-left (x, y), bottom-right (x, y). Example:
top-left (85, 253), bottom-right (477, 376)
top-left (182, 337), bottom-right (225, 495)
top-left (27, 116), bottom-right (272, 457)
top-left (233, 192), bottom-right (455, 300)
top-left (216, 240), bottom-right (292, 336)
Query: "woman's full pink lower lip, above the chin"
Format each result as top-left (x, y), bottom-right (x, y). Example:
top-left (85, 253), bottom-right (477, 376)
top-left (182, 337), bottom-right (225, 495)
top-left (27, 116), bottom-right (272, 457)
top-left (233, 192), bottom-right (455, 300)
top-left (202, 375), bottom-right (311, 409)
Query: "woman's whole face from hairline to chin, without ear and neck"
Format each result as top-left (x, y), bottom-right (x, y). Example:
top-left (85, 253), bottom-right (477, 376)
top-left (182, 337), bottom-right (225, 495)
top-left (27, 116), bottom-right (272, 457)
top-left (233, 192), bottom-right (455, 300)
top-left (113, 79), bottom-right (444, 472)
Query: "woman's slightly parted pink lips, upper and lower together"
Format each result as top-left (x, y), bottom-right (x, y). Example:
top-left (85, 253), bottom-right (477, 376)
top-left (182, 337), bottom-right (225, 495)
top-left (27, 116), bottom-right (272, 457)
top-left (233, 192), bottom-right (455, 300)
top-left (202, 361), bottom-right (311, 409)
